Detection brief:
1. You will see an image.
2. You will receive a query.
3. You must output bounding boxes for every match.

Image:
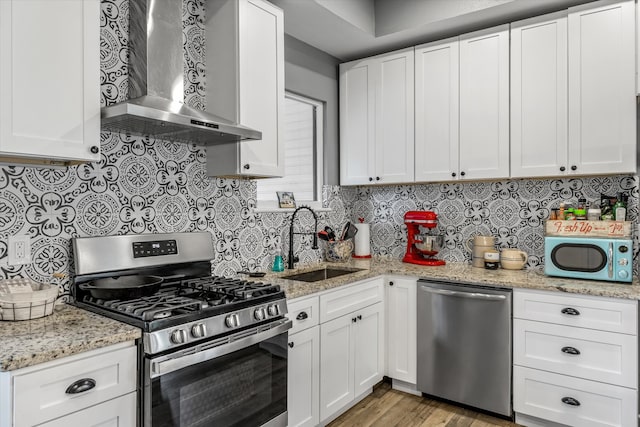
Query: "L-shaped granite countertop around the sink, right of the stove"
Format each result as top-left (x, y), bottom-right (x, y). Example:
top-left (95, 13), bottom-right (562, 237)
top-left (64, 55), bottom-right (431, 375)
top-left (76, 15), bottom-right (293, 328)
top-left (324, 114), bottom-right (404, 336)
top-left (263, 258), bottom-right (640, 300)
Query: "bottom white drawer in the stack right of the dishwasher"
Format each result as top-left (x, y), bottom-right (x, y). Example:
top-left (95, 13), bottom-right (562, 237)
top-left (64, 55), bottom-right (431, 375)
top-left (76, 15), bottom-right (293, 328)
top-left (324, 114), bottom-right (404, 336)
top-left (513, 366), bottom-right (638, 427)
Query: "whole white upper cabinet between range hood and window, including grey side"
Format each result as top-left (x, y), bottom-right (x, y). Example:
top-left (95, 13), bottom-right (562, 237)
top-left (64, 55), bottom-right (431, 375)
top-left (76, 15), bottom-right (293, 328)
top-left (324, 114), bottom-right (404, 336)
top-left (205, 0), bottom-right (285, 178)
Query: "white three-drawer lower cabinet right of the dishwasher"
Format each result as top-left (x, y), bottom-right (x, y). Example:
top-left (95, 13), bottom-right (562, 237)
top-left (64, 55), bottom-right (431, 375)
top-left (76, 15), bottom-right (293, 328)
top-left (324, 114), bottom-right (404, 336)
top-left (513, 289), bottom-right (638, 427)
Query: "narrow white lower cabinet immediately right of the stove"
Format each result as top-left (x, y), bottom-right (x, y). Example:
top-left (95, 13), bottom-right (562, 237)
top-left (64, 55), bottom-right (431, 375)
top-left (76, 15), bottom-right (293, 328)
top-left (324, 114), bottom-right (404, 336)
top-left (287, 296), bottom-right (320, 427)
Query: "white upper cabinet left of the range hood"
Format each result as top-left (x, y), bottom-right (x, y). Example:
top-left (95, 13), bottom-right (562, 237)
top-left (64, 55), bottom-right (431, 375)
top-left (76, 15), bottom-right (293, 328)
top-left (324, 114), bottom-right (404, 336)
top-left (0, 0), bottom-right (100, 165)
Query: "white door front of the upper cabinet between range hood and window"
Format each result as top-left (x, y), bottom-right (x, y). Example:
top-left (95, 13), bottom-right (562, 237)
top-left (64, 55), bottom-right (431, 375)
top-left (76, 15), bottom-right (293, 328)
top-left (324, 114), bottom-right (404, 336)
top-left (238, 0), bottom-right (285, 176)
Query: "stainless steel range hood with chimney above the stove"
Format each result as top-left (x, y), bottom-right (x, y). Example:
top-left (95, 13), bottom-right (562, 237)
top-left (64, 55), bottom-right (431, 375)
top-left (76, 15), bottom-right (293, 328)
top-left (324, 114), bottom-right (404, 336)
top-left (101, 0), bottom-right (262, 146)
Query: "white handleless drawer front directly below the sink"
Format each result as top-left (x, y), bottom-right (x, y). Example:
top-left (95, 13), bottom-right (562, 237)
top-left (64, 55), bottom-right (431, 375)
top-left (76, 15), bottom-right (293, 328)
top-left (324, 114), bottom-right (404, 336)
top-left (320, 277), bottom-right (384, 323)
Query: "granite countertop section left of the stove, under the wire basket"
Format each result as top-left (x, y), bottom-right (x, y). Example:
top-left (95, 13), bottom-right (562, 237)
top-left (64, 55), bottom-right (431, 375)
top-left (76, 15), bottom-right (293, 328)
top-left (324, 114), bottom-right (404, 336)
top-left (0, 304), bottom-right (142, 371)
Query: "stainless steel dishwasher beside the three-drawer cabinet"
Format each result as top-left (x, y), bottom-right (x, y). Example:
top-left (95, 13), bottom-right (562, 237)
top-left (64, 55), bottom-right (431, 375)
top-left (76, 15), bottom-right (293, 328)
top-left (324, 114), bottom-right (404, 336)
top-left (417, 280), bottom-right (512, 417)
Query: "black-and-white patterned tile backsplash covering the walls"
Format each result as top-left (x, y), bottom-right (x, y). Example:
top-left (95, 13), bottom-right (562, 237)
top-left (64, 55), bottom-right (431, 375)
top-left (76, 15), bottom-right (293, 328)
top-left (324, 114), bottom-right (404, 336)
top-left (0, 0), bottom-right (638, 290)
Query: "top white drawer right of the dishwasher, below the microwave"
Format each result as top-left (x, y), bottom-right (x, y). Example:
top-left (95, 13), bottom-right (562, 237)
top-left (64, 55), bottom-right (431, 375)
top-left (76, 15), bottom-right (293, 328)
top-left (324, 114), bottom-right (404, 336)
top-left (513, 289), bottom-right (638, 335)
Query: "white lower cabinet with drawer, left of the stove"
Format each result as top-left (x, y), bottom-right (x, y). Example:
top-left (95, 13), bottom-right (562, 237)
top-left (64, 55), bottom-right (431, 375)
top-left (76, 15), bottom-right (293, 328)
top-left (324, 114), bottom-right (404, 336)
top-left (0, 341), bottom-right (138, 427)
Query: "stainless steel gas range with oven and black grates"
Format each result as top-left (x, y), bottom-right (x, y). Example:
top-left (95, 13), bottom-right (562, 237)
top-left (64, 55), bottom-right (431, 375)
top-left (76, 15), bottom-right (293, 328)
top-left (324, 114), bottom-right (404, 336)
top-left (72, 233), bottom-right (291, 427)
